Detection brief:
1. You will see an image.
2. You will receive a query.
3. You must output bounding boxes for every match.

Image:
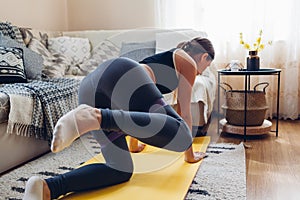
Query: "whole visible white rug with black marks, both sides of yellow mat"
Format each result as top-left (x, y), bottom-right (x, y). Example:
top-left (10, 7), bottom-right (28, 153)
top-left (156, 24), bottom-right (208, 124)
top-left (0, 135), bottom-right (246, 200)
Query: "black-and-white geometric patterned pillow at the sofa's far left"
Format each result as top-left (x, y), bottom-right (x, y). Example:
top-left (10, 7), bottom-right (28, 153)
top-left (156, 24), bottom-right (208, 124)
top-left (0, 46), bottom-right (27, 83)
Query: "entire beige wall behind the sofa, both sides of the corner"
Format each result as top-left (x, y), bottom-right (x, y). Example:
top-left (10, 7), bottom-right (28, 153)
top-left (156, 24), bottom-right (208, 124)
top-left (0, 0), bottom-right (154, 30)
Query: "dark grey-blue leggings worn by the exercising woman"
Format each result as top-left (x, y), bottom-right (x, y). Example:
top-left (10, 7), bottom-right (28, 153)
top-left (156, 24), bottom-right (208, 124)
top-left (46, 58), bottom-right (192, 198)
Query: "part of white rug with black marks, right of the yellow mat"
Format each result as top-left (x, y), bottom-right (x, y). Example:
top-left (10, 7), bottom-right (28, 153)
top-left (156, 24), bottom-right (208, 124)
top-left (186, 143), bottom-right (246, 200)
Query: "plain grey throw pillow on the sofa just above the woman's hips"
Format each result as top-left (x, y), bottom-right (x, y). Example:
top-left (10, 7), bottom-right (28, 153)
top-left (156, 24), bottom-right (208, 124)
top-left (120, 40), bottom-right (156, 62)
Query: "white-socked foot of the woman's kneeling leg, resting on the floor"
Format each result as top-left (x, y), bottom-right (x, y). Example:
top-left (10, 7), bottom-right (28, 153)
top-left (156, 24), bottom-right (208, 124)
top-left (23, 176), bottom-right (50, 200)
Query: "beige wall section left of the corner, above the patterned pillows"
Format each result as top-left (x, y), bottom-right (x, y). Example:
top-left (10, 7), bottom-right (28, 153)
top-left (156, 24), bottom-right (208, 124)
top-left (0, 0), bottom-right (68, 30)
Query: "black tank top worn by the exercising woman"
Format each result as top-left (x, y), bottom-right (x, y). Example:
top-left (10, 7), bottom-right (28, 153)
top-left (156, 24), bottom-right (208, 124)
top-left (140, 48), bottom-right (179, 94)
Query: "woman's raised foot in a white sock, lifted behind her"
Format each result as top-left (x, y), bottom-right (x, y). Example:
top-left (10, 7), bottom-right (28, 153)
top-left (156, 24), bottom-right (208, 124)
top-left (51, 104), bottom-right (101, 153)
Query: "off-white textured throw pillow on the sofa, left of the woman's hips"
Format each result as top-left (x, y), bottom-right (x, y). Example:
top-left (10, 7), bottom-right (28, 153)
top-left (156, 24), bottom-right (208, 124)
top-left (48, 36), bottom-right (91, 65)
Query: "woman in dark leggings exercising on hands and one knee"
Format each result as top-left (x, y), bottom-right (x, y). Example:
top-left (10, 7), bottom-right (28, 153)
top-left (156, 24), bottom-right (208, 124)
top-left (23, 38), bottom-right (215, 200)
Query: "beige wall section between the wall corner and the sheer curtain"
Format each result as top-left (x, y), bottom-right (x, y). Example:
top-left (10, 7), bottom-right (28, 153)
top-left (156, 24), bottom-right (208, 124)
top-left (68, 0), bottom-right (154, 30)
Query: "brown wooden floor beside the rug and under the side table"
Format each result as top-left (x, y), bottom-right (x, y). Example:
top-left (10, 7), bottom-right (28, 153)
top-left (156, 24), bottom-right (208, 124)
top-left (207, 112), bottom-right (300, 200)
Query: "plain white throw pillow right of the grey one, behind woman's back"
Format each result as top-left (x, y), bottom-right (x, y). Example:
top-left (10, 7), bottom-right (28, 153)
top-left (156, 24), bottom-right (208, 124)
top-left (155, 30), bottom-right (207, 53)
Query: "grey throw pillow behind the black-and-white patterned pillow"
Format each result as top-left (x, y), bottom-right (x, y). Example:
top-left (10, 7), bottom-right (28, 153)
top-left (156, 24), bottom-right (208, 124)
top-left (0, 35), bottom-right (43, 80)
